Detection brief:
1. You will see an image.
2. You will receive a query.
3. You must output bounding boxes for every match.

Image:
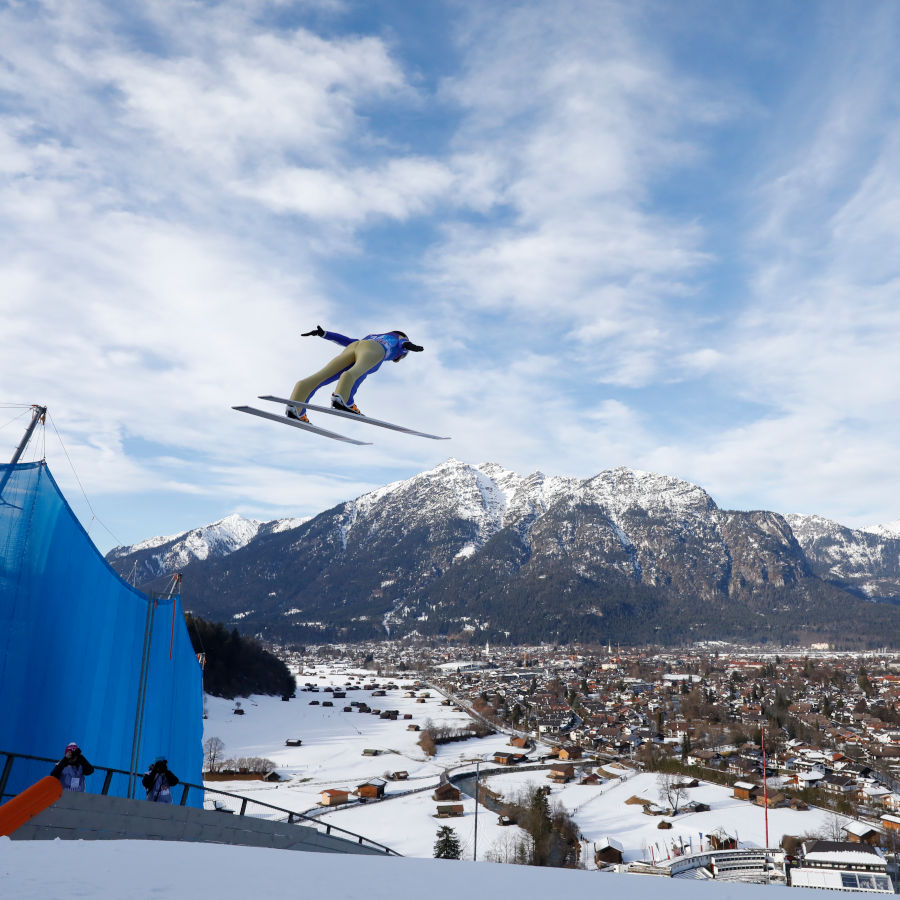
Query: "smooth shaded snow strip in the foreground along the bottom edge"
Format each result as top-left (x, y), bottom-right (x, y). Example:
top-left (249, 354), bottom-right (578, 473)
top-left (0, 836), bottom-right (836, 900)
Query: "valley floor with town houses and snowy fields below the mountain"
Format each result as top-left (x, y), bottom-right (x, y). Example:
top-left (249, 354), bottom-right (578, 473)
top-left (197, 641), bottom-right (900, 892)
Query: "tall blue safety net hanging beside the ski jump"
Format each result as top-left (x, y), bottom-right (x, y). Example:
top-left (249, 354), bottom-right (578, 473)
top-left (0, 463), bottom-right (203, 805)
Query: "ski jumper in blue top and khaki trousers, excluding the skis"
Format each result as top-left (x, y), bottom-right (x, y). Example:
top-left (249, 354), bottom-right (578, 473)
top-left (285, 325), bottom-right (422, 422)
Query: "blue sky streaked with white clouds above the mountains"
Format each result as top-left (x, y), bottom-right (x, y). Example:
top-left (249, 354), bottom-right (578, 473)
top-left (0, 0), bottom-right (900, 550)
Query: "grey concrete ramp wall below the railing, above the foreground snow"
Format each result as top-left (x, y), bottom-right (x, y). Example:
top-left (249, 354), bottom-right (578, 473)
top-left (11, 791), bottom-right (385, 856)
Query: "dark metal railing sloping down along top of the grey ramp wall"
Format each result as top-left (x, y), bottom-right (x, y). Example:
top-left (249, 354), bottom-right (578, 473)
top-left (0, 750), bottom-right (401, 856)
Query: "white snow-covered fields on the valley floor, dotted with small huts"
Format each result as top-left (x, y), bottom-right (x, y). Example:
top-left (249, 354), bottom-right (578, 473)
top-left (197, 670), bottom-right (832, 866)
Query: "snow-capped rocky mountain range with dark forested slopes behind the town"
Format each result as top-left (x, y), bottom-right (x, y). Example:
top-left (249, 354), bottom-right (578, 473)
top-left (110, 460), bottom-right (900, 646)
